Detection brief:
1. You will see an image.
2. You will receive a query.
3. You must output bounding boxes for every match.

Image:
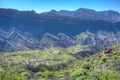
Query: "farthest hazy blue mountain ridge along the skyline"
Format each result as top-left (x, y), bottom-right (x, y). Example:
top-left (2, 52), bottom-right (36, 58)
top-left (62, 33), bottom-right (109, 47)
top-left (0, 8), bottom-right (120, 22)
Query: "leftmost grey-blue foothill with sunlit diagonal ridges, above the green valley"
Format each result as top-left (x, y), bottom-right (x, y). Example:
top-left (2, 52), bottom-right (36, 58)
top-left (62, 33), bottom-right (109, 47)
top-left (0, 28), bottom-right (40, 52)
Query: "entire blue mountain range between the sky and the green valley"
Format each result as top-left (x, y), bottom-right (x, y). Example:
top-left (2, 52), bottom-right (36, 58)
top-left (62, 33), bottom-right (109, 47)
top-left (0, 8), bottom-right (120, 52)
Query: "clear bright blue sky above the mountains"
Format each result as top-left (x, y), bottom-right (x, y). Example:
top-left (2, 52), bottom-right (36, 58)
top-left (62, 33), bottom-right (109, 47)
top-left (0, 0), bottom-right (120, 12)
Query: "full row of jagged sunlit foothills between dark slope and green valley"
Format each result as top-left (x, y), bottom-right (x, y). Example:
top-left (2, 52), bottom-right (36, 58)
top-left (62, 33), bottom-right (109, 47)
top-left (0, 27), bottom-right (120, 52)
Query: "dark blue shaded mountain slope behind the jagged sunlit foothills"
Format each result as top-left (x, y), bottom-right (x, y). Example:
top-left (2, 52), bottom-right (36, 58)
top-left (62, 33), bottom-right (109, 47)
top-left (0, 9), bottom-right (120, 38)
